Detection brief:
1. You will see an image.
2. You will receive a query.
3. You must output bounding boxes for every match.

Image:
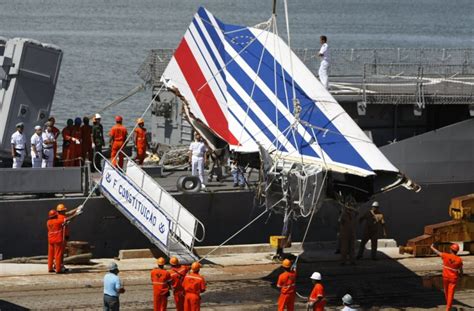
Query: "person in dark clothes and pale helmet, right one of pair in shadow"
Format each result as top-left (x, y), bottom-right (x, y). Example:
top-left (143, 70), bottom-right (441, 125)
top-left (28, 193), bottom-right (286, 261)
top-left (357, 201), bottom-right (387, 260)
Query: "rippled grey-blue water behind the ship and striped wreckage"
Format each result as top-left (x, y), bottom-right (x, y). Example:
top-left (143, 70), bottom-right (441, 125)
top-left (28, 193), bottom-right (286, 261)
top-left (0, 0), bottom-right (474, 131)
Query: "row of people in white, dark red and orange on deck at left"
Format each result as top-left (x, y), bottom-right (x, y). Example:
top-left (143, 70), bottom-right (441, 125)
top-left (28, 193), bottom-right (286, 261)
top-left (11, 113), bottom-right (148, 170)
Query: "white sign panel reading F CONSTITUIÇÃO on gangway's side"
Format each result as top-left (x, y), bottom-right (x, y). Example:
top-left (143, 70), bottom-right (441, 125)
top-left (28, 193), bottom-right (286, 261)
top-left (100, 163), bottom-right (170, 246)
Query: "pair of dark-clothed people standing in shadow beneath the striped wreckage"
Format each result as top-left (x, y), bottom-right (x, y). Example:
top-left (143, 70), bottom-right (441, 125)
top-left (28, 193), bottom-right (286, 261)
top-left (336, 201), bottom-right (387, 265)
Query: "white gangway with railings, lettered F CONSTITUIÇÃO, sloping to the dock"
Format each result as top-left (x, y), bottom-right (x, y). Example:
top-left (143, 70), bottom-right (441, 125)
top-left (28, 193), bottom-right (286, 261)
top-left (100, 155), bottom-right (205, 263)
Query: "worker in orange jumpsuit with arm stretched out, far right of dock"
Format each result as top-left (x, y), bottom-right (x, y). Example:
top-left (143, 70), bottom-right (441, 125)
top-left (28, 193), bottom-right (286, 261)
top-left (431, 244), bottom-right (463, 310)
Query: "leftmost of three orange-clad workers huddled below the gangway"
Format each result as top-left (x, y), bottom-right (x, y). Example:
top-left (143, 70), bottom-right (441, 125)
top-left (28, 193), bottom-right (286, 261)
top-left (150, 257), bottom-right (171, 311)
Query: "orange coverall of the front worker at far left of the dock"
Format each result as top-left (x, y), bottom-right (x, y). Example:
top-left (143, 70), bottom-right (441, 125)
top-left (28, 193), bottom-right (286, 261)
top-left (46, 218), bottom-right (64, 272)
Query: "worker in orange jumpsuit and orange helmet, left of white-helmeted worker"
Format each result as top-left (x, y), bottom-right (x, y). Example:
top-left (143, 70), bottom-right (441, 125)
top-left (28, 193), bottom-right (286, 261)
top-left (277, 259), bottom-right (296, 311)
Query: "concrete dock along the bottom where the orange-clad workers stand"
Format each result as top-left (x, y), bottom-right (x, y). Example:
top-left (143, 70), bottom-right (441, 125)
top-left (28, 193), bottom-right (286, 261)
top-left (0, 244), bottom-right (474, 311)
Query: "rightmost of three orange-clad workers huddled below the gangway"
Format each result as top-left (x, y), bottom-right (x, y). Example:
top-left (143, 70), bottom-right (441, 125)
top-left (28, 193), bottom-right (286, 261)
top-left (183, 262), bottom-right (206, 311)
